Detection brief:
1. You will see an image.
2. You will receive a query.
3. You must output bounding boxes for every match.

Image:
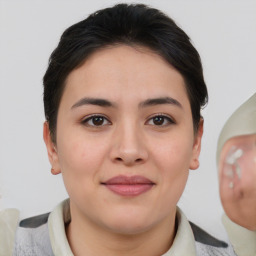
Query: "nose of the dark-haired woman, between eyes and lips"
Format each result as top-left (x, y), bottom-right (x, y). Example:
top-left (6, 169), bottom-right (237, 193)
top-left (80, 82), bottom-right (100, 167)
top-left (110, 122), bottom-right (148, 166)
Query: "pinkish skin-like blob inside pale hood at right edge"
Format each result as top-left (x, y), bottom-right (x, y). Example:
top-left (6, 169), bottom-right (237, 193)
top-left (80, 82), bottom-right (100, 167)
top-left (219, 134), bottom-right (256, 230)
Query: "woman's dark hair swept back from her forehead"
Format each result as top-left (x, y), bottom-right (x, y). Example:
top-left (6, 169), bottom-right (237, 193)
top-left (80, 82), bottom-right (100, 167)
top-left (43, 4), bottom-right (208, 142)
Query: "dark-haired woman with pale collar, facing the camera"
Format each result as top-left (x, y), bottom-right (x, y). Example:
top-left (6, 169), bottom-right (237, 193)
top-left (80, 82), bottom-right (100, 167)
top-left (1, 4), bottom-right (255, 256)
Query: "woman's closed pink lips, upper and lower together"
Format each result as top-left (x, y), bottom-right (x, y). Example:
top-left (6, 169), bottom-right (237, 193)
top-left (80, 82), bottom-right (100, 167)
top-left (102, 175), bottom-right (155, 196)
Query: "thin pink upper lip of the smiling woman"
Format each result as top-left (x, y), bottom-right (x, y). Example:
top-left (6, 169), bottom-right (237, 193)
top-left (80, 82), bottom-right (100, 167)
top-left (102, 175), bottom-right (155, 185)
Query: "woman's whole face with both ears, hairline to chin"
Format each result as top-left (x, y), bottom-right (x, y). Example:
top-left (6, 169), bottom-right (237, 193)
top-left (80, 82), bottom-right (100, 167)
top-left (44, 46), bottom-right (202, 234)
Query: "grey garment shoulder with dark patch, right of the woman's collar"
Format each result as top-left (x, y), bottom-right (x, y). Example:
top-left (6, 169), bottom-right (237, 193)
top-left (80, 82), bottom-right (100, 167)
top-left (189, 222), bottom-right (236, 256)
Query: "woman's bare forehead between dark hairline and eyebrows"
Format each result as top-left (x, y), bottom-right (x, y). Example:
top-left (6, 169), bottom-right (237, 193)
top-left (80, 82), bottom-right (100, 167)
top-left (63, 45), bottom-right (188, 107)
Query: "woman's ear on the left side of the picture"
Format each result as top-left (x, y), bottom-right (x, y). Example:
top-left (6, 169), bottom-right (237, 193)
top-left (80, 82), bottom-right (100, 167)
top-left (43, 122), bottom-right (61, 175)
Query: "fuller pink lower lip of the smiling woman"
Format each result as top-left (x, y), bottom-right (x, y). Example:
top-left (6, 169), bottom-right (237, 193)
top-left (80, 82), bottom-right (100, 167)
top-left (105, 184), bottom-right (153, 196)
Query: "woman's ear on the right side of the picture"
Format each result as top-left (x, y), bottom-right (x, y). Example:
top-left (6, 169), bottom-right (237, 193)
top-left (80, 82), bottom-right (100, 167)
top-left (189, 118), bottom-right (204, 170)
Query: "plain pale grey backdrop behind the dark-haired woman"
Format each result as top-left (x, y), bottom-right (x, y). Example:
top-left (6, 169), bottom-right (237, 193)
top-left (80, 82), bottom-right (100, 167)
top-left (0, 0), bottom-right (256, 239)
